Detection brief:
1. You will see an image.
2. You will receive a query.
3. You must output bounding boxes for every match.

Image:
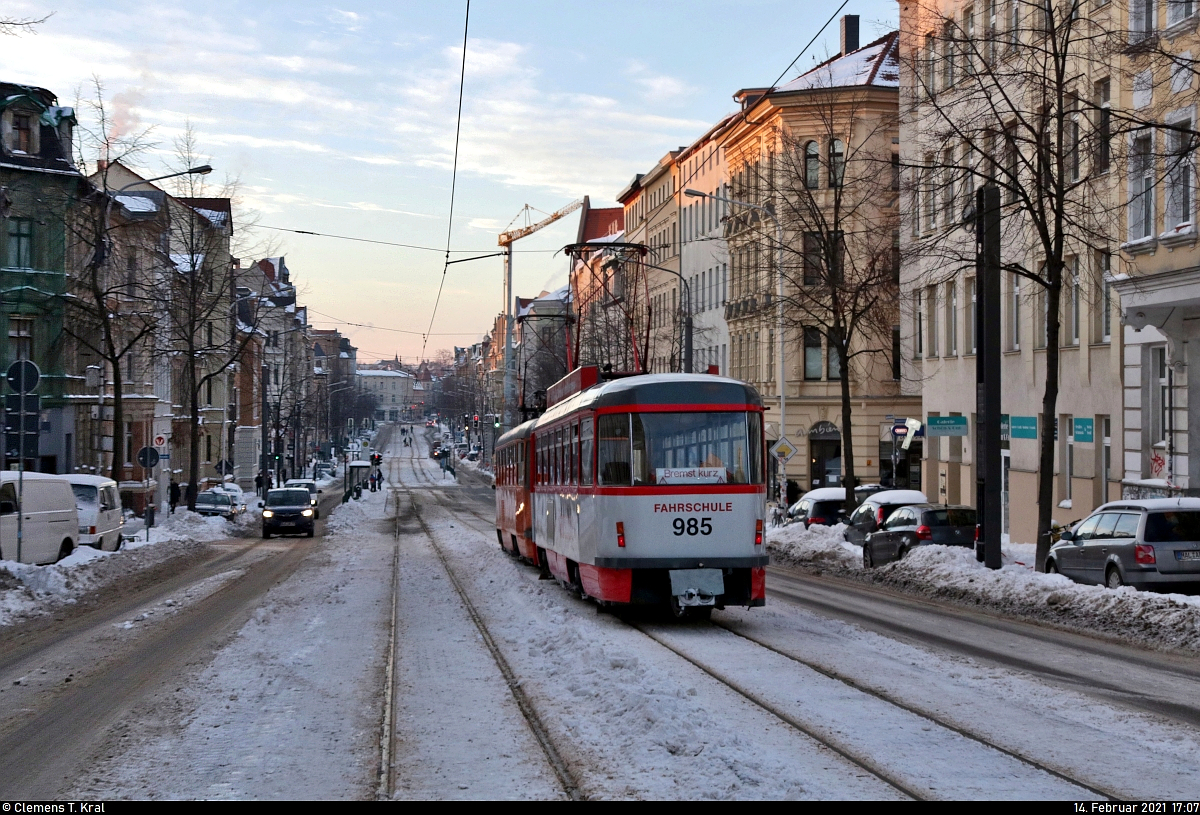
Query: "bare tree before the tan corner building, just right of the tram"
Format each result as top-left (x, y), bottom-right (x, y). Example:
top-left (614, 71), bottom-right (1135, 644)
top-left (726, 65), bottom-right (899, 509)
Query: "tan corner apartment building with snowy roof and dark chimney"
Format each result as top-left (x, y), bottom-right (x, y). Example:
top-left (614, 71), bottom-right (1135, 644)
top-left (719, 17), bottom-right (922, 490)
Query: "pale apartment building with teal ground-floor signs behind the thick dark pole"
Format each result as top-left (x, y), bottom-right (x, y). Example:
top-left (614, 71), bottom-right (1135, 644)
top-left (900, 0), bottom-right (1128, 543)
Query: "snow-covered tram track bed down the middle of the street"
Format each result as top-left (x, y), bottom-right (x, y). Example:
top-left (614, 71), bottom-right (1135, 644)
top-left (6, 424), bottom-right (1200, 801)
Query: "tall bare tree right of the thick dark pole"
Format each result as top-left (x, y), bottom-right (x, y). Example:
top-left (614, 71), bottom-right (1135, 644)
top-left (901, 0), bottom-right (1123, 570)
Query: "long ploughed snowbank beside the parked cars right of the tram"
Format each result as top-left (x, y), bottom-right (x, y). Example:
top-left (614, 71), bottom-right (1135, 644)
top-left (767, 525), bottom-right (1200, 652)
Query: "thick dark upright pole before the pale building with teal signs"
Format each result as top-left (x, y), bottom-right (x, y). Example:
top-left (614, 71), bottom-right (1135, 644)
top-left (974, 184), bottom-right (1003, 569)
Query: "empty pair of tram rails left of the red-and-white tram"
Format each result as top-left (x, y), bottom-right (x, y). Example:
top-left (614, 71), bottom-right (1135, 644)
top-left (377, 436), bottom-right (583, 801)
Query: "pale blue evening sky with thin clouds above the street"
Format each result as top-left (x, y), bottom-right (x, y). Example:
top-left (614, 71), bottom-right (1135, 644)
top-left (0, 0), bottom-right (898, 361)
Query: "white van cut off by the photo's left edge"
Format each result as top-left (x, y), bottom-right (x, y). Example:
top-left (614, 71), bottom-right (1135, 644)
top-left (0, 471), bottom-right (79, 563)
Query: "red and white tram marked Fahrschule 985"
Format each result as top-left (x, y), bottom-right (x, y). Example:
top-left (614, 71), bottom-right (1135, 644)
top-left (497, 370), bottom-right (768, 616)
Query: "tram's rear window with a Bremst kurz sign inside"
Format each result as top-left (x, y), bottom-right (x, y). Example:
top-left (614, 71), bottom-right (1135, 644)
top-left (596, 412), bottom-right (763, 486)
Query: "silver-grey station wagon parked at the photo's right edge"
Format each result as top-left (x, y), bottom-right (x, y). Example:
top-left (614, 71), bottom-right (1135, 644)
top-left (1045, 498), bottom-right (1200, 591)
